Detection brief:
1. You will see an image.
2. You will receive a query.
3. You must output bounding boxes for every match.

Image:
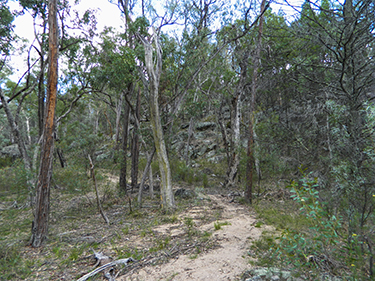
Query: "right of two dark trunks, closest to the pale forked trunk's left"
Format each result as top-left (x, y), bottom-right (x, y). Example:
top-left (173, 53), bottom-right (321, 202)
top-left (131, 89), bottom-right (141, 190)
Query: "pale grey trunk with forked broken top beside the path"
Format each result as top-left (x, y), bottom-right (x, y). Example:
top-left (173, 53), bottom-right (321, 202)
top-left (140, 30), bottom-right (175, 210)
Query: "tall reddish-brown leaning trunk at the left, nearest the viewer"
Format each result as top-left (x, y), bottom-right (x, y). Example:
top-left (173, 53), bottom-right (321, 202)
top-left (31, 0), bottom-right (58, 247)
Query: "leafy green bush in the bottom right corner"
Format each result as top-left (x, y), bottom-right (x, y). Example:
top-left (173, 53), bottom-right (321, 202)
top-left (272, 170), bottom-right (372, 280)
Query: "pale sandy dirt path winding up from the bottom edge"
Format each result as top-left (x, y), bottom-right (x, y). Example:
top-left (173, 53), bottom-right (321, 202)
top-left (118, 195), bottom-right (274, 281)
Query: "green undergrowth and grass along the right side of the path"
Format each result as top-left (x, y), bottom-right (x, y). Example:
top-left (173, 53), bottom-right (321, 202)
top-left (252, 167), bottom-right (372, 280)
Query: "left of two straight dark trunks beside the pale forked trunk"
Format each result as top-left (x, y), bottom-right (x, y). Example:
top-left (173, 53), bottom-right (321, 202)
top-left (119, 91), bottom-right (131, 194)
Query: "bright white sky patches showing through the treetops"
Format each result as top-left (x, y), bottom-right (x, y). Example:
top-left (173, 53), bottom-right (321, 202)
top-left (9, 0), bottom-right (303, 81)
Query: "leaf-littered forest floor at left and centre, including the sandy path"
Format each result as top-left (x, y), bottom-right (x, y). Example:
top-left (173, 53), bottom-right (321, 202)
top-left (0, 170), bottom-right (274, 281)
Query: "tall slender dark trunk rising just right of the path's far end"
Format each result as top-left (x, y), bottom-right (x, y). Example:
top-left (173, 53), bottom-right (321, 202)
top-left (245, 0), bottom-right (268, 204)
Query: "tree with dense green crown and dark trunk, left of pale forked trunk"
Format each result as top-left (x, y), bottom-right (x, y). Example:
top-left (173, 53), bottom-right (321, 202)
top-left (87, 25), bottom-right (137, 193)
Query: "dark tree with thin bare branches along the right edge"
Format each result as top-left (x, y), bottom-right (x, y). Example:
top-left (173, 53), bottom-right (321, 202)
top-left (318, 1), bottom-right (375, 236)
